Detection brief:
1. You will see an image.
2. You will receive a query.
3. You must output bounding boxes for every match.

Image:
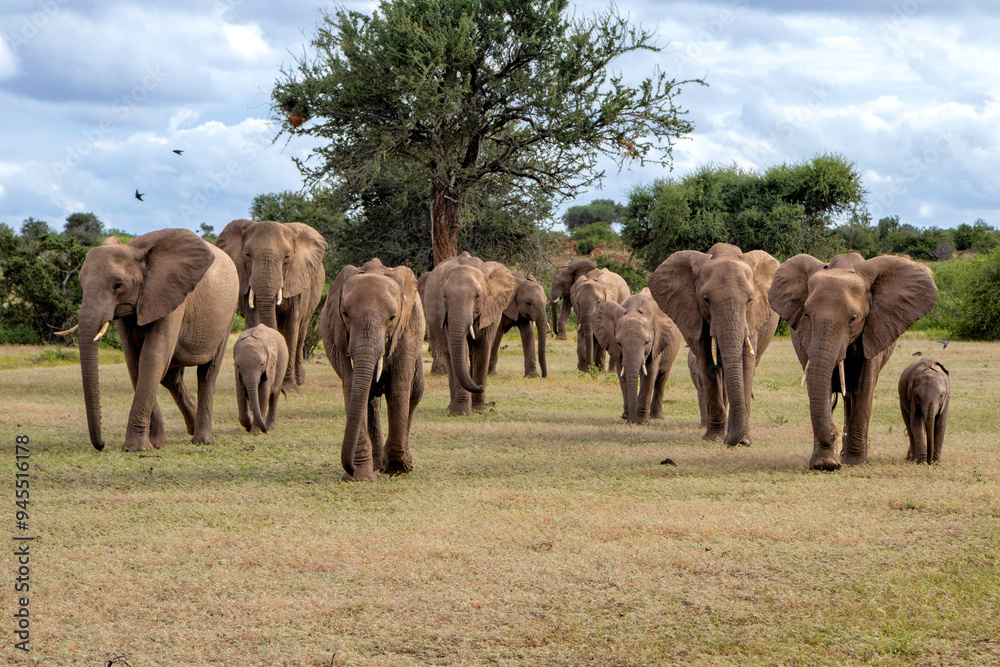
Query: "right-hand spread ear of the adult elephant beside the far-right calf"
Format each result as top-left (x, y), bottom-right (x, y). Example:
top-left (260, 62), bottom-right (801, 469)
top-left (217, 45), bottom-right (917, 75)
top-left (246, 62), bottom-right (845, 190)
top-left (857, 255), bottom-right (937, 359)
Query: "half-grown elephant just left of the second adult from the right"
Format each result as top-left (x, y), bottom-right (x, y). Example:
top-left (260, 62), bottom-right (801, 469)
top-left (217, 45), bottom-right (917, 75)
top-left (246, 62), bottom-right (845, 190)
top-left (593, 288), bottom-right (681, 424)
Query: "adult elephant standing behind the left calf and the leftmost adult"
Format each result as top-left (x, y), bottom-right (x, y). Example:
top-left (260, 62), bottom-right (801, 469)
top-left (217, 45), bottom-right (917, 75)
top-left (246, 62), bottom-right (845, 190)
top-left (216, 220), bottom-right (326, 389)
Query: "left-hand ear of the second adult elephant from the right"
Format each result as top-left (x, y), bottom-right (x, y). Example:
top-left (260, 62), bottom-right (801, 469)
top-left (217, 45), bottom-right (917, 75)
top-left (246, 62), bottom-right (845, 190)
top-left (649, 250), bottom-right (709, 340)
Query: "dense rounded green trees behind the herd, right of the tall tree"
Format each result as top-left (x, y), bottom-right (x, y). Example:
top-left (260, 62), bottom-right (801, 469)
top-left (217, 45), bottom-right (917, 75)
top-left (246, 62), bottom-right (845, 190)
top-left (622, 155), bottom-right (865, 271)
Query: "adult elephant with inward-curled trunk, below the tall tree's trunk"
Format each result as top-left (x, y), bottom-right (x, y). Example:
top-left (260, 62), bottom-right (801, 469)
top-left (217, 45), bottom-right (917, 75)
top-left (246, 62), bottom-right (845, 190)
top-left (424, 252), bottom-right (517, 415)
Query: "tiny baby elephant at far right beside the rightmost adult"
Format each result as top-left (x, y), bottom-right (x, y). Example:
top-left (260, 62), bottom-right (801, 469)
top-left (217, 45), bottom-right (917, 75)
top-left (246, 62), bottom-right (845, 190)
top-left (899, 357), bottom-right (951, 463)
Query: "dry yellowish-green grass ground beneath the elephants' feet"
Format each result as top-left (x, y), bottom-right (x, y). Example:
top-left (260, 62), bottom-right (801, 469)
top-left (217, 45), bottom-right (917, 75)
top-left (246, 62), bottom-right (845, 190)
top-left (0, 332), bottom-right (1000, 667)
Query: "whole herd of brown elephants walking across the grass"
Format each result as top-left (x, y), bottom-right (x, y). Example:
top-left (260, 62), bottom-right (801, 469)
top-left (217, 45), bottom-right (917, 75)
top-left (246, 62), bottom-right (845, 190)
top-left (54, 220), bottom-right (949, 480)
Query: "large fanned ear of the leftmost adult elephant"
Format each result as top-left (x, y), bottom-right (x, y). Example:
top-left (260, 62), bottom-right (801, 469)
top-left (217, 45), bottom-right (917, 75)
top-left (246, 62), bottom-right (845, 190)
top-left (129, 229), bottom-right (215, 326)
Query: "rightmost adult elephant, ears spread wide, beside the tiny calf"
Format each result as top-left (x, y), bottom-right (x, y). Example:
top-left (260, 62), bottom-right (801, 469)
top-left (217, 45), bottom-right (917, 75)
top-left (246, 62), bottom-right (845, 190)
top-left (770, 253), bottom-right (937, 470)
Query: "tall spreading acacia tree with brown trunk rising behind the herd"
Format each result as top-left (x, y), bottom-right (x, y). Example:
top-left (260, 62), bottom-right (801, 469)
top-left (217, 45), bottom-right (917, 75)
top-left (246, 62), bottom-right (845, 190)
top-left (272, 0), bottom-right (701, 263)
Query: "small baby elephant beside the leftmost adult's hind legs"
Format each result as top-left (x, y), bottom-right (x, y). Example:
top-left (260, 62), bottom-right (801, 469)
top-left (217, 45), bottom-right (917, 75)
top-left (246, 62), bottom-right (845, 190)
top-left (233, 324), bottom-right (288, 435)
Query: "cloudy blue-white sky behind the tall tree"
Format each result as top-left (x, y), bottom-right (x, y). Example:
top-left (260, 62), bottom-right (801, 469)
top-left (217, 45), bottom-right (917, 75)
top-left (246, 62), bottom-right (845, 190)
top-left (0, 0), bottom-right (1000, 233)
